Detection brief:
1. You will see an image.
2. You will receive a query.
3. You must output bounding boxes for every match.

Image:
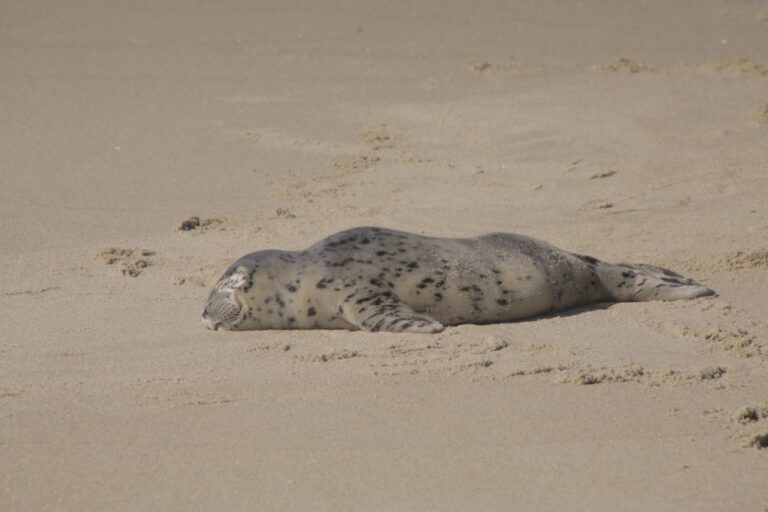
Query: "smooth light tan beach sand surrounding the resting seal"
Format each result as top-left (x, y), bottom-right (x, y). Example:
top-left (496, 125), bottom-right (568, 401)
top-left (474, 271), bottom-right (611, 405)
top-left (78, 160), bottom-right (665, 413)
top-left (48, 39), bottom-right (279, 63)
top-left (0, 0), bottom-right (768, 512)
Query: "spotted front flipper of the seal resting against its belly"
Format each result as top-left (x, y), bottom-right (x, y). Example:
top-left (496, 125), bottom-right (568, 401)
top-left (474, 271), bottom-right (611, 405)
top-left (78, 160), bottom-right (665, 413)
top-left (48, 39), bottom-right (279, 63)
top-left (341, 288), bottom-right (445, 334)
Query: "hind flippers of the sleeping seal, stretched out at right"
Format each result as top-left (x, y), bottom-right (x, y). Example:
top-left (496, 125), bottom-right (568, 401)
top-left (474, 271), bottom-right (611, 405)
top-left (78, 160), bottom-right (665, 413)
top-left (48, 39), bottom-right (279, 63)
top-left (582, 257), bottom-right (715, 302)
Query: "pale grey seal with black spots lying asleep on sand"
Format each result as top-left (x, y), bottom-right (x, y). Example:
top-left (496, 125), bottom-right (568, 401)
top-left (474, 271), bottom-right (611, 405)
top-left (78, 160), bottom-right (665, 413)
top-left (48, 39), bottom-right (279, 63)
top-left (203, 227), bottom-right (715, 333)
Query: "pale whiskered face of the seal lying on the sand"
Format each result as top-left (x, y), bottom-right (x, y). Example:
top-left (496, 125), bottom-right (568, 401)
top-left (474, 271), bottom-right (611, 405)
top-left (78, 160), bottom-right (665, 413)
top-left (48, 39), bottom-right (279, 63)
top-left (203, 267), bottom-right (249, 331)
